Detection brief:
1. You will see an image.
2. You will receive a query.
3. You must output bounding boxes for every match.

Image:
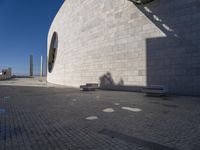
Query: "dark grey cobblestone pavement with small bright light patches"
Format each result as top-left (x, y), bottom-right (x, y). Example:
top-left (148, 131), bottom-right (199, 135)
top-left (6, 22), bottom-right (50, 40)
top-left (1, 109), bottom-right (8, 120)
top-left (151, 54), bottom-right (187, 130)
top-left (0, 81), bottom-right (200, 150)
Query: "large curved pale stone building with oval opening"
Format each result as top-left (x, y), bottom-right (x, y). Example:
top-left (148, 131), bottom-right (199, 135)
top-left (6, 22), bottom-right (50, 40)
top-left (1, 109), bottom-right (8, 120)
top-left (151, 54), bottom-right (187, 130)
top-left (47, 0), bottom-right (200, 95)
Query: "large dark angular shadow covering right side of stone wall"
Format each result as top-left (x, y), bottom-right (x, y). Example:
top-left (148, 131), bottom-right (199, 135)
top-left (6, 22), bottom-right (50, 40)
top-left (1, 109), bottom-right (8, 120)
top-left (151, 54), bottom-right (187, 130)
top-left (131, 0), bottom-right (200, 95)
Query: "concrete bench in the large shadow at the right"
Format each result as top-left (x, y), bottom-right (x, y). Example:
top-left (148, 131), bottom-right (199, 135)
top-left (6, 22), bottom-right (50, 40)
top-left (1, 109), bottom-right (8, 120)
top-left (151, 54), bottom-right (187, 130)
top-left (142, 85), bottom-right (168, 96)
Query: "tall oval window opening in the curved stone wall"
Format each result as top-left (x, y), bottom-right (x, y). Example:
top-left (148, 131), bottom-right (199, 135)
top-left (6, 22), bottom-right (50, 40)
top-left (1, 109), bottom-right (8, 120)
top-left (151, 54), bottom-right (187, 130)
top-left (48, 32), bottom-right (58, 73)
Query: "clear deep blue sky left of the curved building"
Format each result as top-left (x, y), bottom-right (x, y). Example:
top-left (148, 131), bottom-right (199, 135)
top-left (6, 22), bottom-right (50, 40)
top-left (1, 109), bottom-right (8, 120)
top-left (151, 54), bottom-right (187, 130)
top-left (0, 0), bottom-right (64, 74)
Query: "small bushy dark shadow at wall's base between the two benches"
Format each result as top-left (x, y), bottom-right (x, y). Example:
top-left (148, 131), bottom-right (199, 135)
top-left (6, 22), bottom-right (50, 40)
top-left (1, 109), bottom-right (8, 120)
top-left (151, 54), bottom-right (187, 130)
top-left (99, 72), bottom-right (143, 92)
